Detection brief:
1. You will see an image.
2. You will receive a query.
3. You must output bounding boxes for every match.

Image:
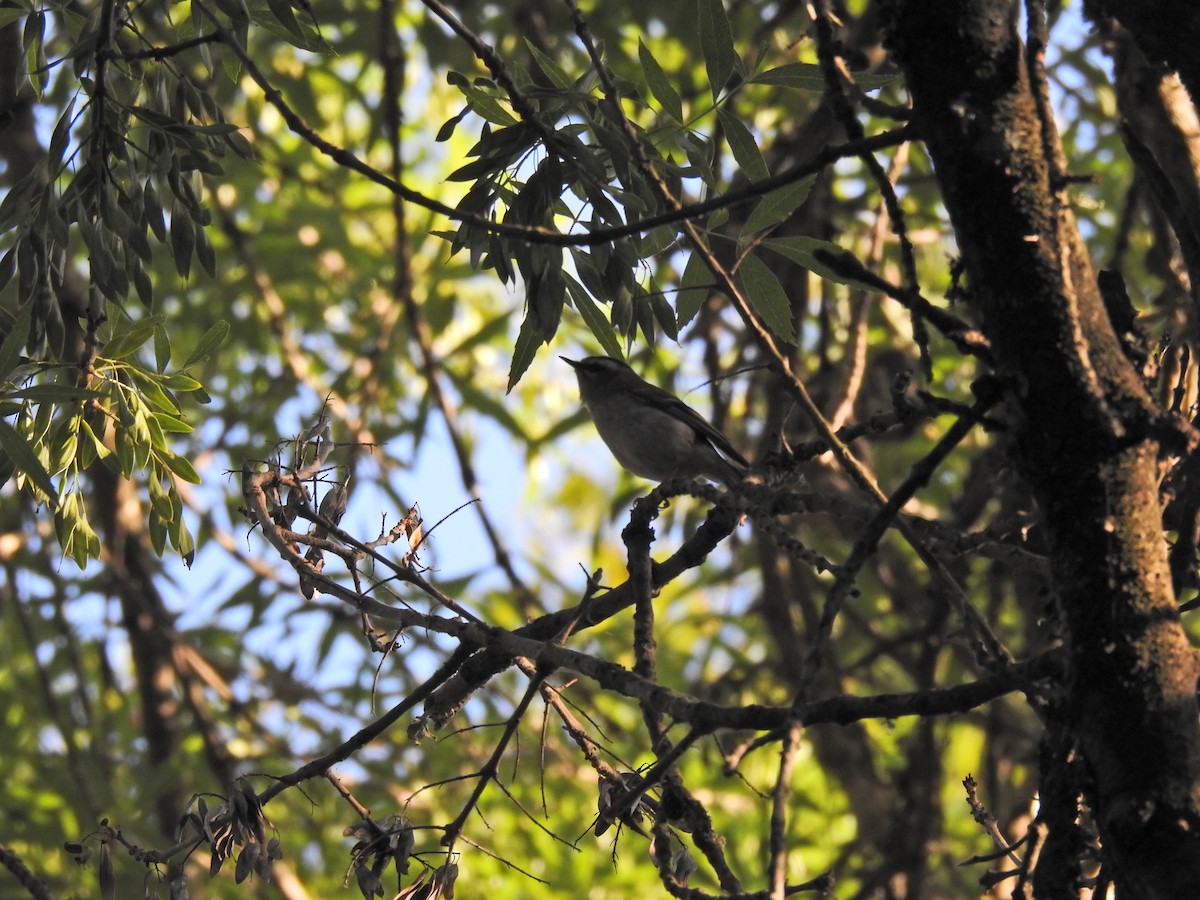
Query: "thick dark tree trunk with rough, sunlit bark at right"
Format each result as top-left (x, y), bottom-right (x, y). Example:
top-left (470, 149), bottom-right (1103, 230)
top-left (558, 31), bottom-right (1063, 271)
top-left (888, 0), bottom-right (1200, 898)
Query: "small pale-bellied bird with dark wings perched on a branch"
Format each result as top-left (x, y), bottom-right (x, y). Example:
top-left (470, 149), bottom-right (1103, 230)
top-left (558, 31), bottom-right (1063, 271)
top-left (559, 356), bottom-right (750, 485)
